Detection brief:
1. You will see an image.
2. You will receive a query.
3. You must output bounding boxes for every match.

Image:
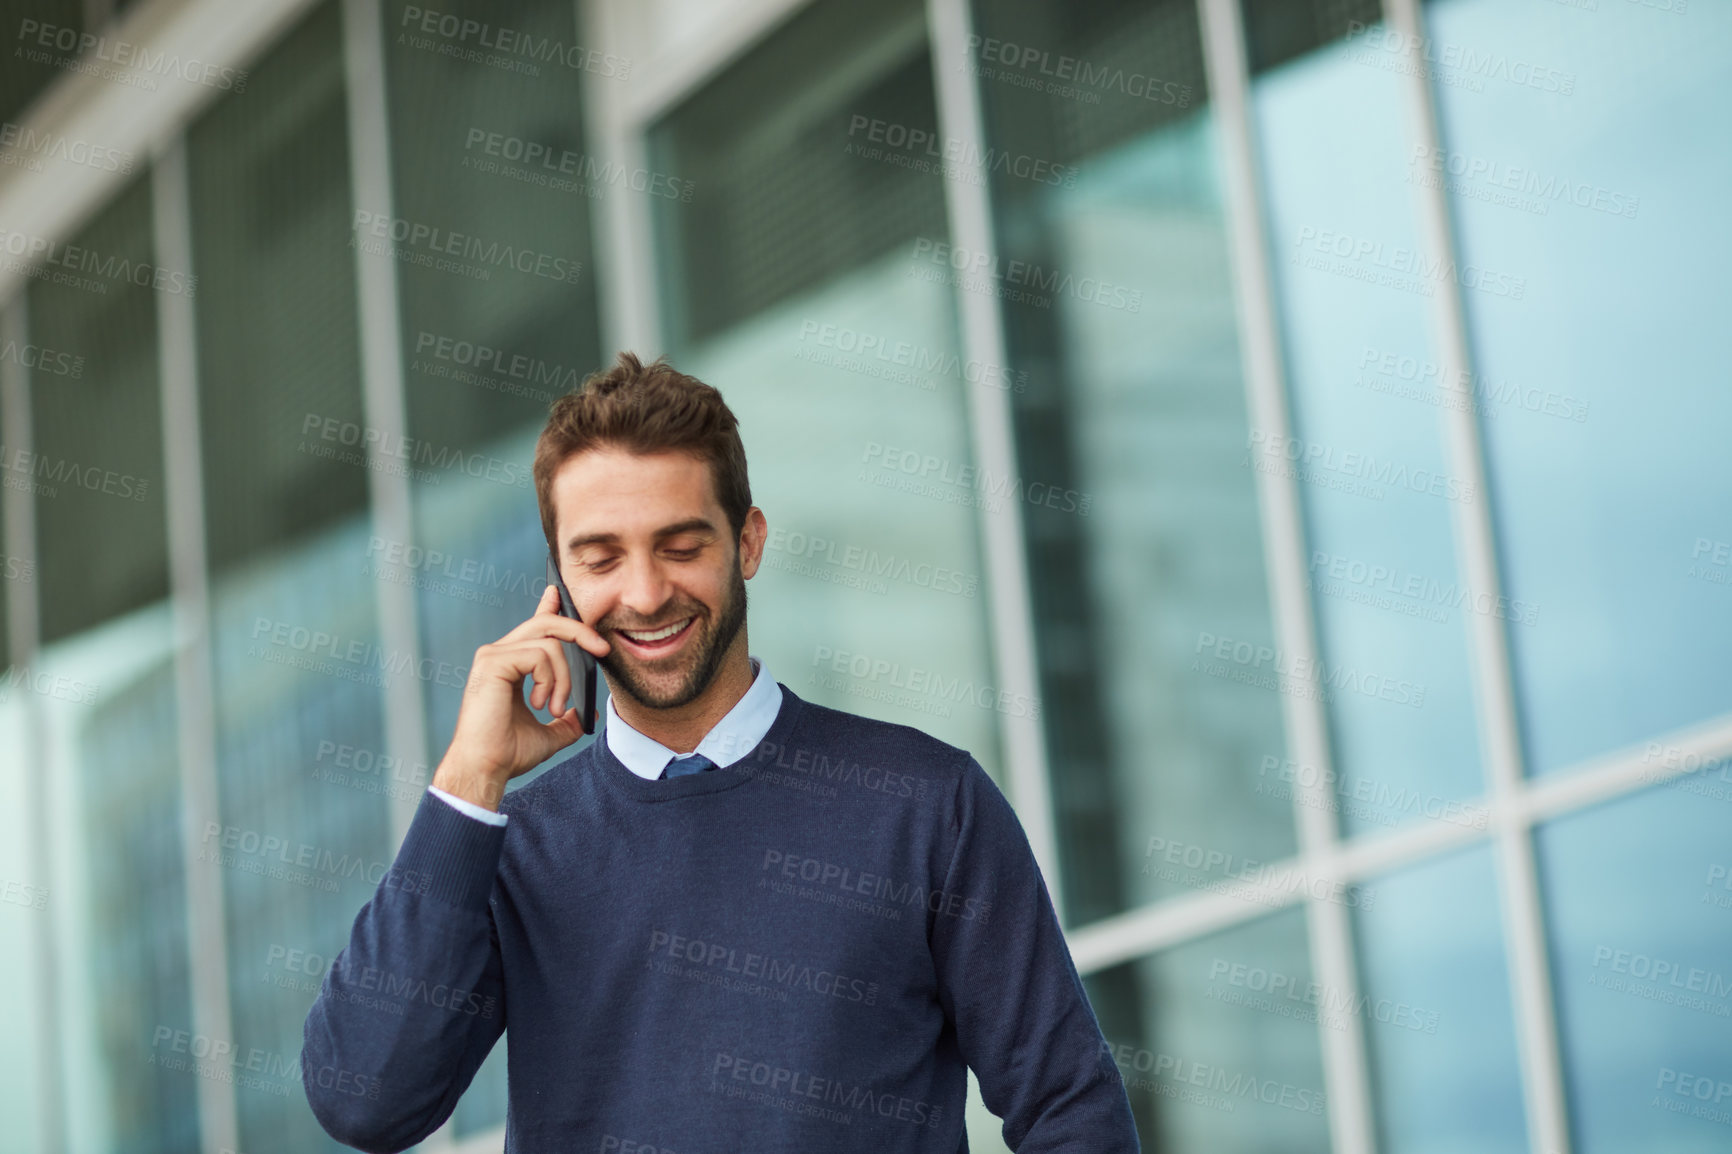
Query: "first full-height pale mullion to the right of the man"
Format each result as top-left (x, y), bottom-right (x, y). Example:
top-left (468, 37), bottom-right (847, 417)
top-left (1199, 0), bottom-right (1375, 1154)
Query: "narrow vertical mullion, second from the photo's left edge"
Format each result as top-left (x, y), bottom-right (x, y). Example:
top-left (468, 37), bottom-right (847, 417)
top-left (151, 137), bottom-right (241, 1154)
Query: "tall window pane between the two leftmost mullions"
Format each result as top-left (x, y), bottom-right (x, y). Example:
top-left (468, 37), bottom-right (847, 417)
top-left (13, 170), bottom-right (197, 1154)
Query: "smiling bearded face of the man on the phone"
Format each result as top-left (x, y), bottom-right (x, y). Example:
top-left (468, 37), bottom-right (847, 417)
top-left (551, 447), bottom-right (764, 709)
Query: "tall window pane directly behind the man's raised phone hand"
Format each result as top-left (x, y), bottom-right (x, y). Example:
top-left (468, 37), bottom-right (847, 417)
top-left (384, 0), bottom-right (609, 1137)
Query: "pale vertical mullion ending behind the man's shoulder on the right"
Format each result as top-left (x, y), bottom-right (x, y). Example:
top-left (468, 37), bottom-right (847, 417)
top-left (927, 0), bottom-right (1063, 920)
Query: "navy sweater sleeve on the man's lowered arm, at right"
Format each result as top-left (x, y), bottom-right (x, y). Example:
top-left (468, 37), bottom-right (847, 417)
top-left (932, 757), bottom-right (1141, 1154)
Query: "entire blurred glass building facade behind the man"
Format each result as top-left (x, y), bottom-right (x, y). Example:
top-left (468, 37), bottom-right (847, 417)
top-left (0, 0), bottom-right (1732, 1154)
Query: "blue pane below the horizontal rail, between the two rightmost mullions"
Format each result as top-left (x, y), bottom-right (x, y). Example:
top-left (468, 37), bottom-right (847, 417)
top-left (1354, 846), bottom-right (1528, 1154)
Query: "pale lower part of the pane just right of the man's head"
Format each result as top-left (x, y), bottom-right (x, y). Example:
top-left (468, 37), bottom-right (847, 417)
top-left (682, 255), bottom-right (1011, 773)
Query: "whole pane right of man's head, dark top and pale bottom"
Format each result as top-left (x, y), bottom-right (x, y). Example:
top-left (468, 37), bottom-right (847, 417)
top-left (651, 3), bottom-right (1004, 773)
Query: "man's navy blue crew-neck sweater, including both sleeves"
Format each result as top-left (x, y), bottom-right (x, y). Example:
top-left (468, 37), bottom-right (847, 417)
top-left (301, 686), bottom-right (1138, 1154)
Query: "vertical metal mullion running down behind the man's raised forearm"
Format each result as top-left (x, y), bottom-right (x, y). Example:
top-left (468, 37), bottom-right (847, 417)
top-left (343, 0), bottom-right (428, 846)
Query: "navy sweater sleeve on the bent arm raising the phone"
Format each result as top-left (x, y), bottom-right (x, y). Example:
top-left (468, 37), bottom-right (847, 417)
top-left (301, 795), bottom-right (506, 1152)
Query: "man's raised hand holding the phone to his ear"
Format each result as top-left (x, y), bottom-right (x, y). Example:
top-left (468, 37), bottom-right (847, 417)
top-left (433, 586), bottom-right (613, 811)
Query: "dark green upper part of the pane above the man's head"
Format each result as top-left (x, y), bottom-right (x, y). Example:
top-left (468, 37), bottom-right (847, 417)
top-left (650, 0), bottom-right (958, 350)
